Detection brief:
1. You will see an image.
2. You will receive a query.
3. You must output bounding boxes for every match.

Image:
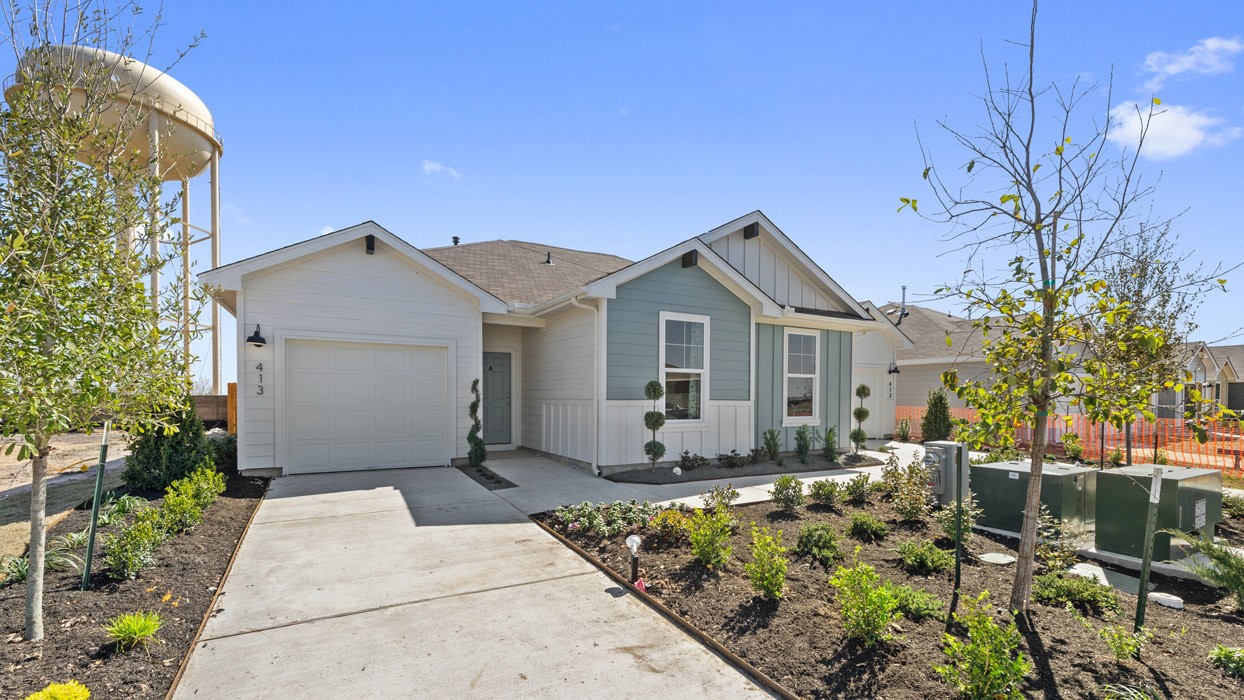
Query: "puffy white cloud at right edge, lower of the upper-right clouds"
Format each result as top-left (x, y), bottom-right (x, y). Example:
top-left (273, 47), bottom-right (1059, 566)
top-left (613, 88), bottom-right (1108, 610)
top-left (1110, 102), bottom-right (1244, 160)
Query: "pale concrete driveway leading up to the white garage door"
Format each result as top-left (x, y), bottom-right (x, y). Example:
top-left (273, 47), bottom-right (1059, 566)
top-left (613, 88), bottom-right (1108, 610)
top-left (174, 458), bottom-right (768, 699)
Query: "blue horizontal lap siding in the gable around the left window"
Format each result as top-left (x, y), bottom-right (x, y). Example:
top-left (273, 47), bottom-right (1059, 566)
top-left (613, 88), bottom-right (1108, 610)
top-left (606, 261), bottom-right (751, 402)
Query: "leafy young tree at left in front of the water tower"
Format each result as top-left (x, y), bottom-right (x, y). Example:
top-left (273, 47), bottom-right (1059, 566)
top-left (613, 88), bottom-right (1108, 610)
top-left (0, 1), bottom-right (201, 640)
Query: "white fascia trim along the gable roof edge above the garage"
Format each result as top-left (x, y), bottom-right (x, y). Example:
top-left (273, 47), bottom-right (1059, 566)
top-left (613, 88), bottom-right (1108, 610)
top-left (199, 221), bottom-right (508, 313)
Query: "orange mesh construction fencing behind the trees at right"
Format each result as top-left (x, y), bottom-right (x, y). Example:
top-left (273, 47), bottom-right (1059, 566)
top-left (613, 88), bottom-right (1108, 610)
top-left (894, 405), bottom-right (1244, 476)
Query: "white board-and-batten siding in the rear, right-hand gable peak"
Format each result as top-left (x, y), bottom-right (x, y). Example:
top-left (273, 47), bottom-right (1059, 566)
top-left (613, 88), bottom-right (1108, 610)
top-left (712, 229), bottom-right (847, 311)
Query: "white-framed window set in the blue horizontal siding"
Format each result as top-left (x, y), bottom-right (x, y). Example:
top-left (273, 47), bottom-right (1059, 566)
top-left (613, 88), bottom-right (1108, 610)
top-left (661, 311), bottom-right (709, 420)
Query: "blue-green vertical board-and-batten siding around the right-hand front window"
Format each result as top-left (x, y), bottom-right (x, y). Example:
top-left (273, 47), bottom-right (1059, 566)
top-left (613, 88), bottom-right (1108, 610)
top-left (756, 323), bottom-right (852, 450)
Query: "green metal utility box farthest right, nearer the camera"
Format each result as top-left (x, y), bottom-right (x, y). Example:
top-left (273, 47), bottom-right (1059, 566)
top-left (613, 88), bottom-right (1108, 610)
top-left (1095, 464), bottom-right (1223, 561)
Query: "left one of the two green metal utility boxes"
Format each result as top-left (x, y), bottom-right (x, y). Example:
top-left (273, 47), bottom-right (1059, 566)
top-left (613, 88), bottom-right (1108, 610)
top-left (972, 461), bottom-right (1098, 533)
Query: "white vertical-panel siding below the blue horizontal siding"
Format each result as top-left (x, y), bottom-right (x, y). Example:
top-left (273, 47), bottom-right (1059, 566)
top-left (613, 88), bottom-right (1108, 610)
top-left (601, 400), bottom-right (755, 466)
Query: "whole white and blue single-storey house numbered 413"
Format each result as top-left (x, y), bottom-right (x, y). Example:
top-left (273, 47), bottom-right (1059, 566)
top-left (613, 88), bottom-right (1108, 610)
top-left (200, 211), bottom-right (909, 474)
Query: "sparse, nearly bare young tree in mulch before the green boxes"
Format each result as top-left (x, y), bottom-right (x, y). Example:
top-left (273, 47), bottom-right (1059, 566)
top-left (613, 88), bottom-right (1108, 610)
top-left (899, 1), bottom-right (1224, 613)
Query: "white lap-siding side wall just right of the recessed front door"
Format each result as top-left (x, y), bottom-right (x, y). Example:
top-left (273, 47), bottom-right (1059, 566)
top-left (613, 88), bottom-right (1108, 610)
top-left (521, 307), bottom-right (596, 463)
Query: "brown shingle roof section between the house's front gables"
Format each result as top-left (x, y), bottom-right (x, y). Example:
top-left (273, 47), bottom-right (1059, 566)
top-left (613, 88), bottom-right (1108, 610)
top-left (420, 240), bottom-right (631, 305)
